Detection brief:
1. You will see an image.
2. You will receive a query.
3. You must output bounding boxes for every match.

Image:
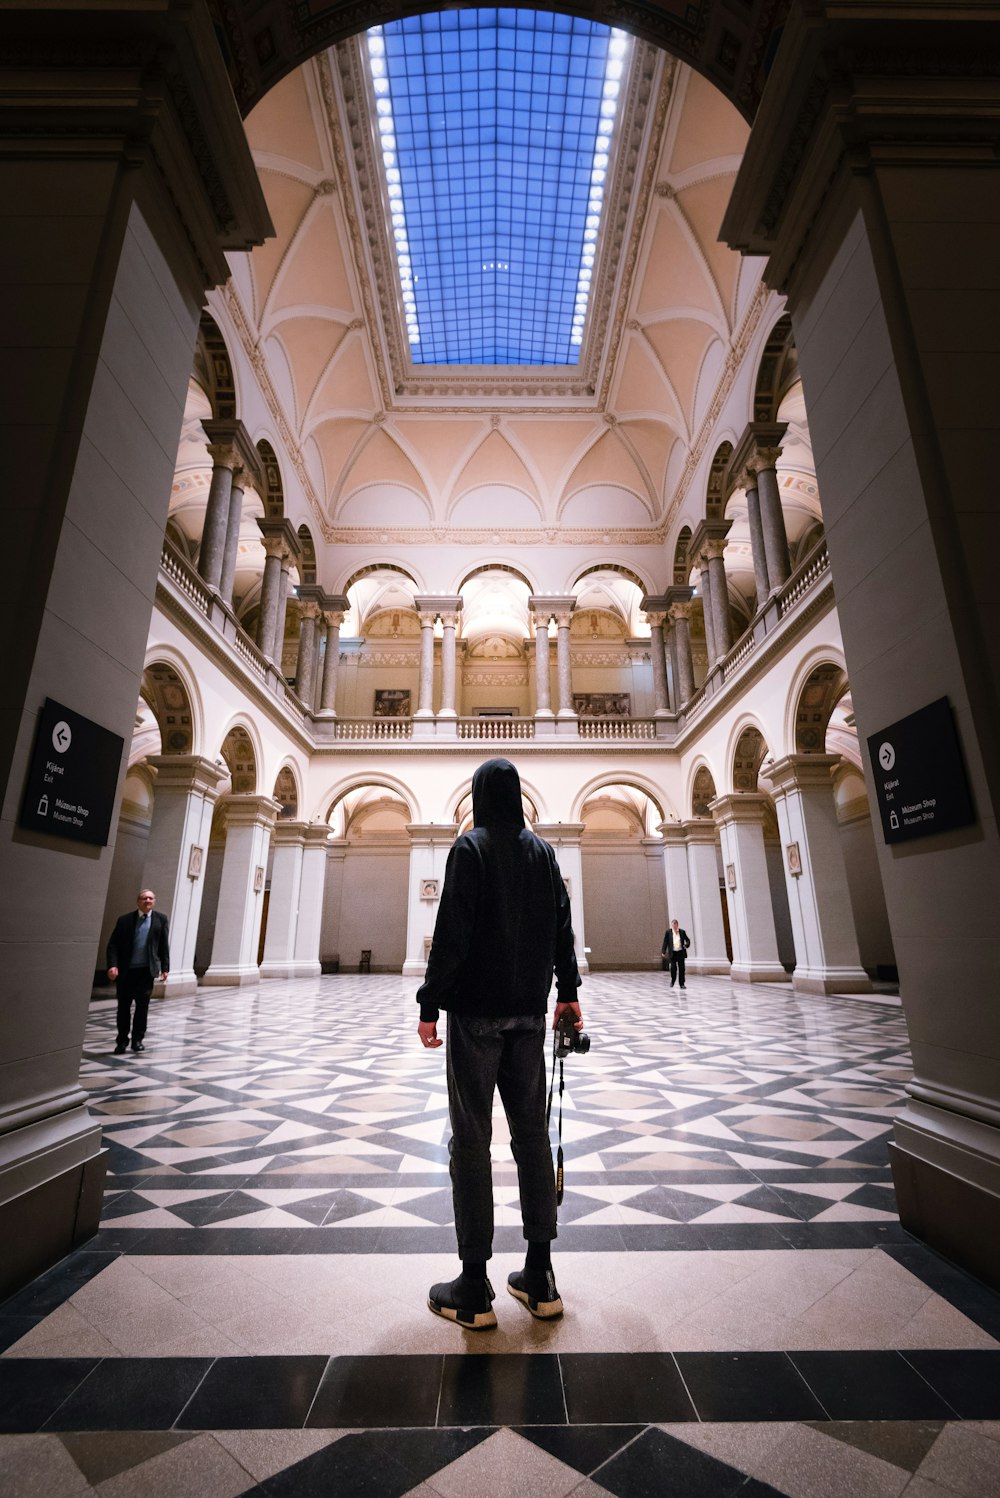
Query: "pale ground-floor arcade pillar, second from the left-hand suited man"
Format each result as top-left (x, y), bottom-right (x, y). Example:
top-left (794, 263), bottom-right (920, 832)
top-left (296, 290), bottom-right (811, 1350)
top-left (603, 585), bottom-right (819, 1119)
top-left (202, 795), bottom-right (281, 987)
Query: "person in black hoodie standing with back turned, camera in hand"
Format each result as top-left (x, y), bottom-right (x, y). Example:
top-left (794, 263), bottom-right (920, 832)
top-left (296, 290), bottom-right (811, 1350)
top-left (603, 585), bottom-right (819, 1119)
top-left (416, 759), bottom-right (584, 1330)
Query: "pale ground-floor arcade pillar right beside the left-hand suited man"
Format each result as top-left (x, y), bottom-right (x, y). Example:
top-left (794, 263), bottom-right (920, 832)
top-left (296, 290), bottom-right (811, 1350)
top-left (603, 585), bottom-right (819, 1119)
top-left (142, 755), bottom-right (226, 998)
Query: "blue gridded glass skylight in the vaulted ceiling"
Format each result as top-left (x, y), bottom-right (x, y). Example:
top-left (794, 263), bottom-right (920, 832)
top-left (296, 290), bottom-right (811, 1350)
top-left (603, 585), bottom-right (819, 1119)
top-left (367, 10), bottom-right (629, 364)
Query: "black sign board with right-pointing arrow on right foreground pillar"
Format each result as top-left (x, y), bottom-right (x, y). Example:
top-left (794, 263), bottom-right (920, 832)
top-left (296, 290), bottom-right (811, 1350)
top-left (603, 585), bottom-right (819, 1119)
top-left (868, 697), bottom-right (976, 843)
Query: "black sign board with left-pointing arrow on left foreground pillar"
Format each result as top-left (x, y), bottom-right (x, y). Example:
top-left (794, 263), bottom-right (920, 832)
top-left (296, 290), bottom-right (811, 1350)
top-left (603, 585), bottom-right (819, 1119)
top-left (19, 697), bottom-right (124, 846)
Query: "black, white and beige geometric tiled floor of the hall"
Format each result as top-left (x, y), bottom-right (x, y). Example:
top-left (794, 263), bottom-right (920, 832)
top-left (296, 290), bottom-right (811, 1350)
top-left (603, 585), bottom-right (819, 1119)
top-left (0, 974), bottom-right (1000, 1498)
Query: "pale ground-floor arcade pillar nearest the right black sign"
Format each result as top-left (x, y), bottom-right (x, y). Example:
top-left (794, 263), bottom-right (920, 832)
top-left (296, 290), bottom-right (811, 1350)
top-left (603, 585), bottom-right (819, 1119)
top-left (763, 753), bottom-right (871, 993)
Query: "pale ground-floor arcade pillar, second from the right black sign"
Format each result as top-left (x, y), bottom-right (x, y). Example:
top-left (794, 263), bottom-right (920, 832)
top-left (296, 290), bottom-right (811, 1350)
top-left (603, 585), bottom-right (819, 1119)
top-left (711, 791), bottom-right (787, 983)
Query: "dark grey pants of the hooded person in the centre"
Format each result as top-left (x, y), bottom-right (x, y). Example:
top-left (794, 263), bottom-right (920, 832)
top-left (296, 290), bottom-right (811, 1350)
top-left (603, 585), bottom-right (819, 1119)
top-left (448, 1014), bottom-right (555, 1260)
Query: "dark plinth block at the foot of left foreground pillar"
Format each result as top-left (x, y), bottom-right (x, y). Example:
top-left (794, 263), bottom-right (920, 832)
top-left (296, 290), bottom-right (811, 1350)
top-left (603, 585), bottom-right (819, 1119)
top-left (0, 1149), bottom-right (108, 1299)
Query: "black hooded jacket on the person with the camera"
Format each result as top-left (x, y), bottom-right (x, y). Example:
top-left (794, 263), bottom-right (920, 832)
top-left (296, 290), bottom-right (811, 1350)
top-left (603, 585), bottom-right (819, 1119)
top-left (416, 759), bottom-right (579, 1020)
